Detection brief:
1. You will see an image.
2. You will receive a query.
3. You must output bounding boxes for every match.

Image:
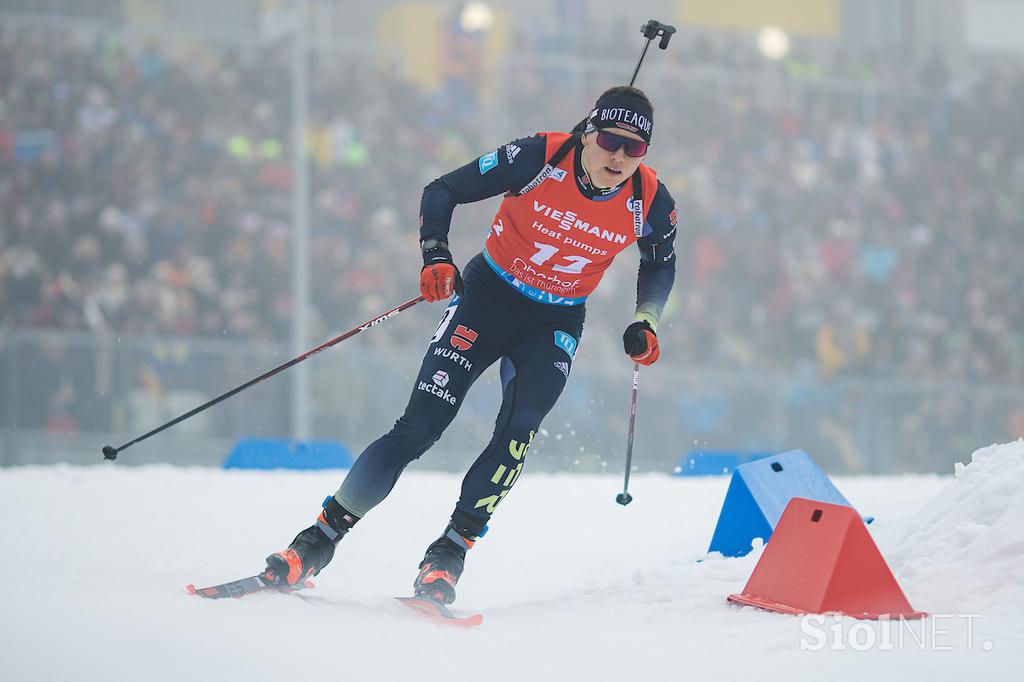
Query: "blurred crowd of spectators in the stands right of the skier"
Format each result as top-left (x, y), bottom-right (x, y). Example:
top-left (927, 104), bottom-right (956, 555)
top-left (647, 69), bottom-right (1024, 384)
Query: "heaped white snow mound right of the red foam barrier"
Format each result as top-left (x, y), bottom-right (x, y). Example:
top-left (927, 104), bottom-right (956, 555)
top-left (887, 438), bottom-right (1024, 613)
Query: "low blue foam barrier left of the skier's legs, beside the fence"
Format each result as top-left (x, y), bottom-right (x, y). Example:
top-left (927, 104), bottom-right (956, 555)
top-left (223, 438), bottom-right (353, 470)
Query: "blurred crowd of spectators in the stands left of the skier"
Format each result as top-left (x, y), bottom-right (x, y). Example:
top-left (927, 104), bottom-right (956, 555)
top-left (0, 26), bottom-right (465, 340)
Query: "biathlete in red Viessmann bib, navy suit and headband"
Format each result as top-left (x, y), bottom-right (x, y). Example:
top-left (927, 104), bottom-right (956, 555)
top-left (261, 86), bottom-right (676, 603)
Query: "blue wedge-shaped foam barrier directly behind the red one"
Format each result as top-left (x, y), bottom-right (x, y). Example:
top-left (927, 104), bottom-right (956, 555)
top-left (708, 450), bottom-right (853, 556)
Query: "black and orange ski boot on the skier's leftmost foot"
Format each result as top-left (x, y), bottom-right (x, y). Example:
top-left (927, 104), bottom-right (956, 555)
top-left (260, 496), bottom-right (359, 587)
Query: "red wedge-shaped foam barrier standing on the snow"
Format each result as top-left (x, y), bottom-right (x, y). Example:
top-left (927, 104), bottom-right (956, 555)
top-left (729, 498), bottom-right (927, 620)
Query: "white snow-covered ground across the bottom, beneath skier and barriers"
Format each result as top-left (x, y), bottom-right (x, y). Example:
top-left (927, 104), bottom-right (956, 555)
top-left (0, 441), bottom-right (1024, 682)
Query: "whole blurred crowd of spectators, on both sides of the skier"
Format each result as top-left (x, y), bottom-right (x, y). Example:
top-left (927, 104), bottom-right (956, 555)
top-left (0, 21), bottom-right (1024, 448)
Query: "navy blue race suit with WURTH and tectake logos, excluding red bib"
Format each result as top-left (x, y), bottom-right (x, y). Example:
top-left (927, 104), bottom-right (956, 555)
top-left (335, 135), bottom-right (676, 537)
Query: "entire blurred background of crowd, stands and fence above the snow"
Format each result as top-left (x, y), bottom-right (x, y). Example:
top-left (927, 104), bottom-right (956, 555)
top-left (0, 2), bottom-right (1024, 471)
